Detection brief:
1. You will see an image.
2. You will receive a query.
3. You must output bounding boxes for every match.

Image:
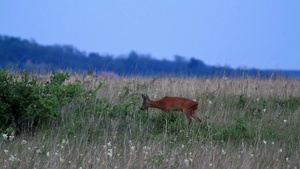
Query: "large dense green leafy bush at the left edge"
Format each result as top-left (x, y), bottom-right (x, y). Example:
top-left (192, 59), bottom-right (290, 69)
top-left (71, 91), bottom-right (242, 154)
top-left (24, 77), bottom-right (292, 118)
top-left (0, 67), bottom-right (100, 133)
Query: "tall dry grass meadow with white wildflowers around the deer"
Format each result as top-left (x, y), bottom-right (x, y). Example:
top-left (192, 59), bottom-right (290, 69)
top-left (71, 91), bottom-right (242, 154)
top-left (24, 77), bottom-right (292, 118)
top-left (0, 69), bottom-right (300, 169)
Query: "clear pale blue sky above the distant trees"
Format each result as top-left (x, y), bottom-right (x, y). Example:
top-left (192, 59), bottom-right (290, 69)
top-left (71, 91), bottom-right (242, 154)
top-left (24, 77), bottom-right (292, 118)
top-left (0, 0), bottom-right (300, 70)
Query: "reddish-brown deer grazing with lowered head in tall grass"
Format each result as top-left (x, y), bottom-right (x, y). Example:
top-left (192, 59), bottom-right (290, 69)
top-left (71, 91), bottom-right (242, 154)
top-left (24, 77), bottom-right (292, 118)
top-left (141, 94), bottom-right (201, 125)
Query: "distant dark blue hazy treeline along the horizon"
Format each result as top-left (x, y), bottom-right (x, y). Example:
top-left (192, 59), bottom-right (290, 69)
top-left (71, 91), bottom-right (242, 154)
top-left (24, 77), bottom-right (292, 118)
top-left (0, 36), bottom-right (292, 77)
